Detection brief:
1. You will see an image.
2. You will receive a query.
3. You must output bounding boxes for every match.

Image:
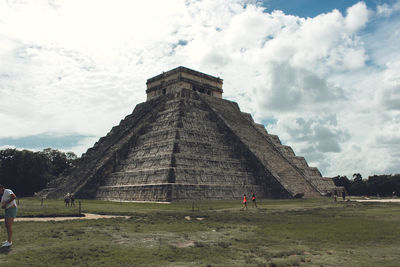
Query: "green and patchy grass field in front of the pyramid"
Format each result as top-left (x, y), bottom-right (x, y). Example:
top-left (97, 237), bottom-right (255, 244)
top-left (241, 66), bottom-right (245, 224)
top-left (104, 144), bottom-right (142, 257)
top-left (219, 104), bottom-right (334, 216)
top-left (0, 198), bottom-right (400, 267)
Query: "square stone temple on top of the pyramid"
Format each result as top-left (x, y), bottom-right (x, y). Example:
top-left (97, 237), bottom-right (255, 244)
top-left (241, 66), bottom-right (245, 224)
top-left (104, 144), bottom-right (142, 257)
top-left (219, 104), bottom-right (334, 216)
top-left (146, 66), bottom-right (223, 100)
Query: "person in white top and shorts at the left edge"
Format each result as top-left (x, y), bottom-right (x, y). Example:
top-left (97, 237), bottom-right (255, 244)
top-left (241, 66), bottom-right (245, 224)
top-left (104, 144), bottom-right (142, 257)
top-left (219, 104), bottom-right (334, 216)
top-left (0, 184), bottom-right (17, 247)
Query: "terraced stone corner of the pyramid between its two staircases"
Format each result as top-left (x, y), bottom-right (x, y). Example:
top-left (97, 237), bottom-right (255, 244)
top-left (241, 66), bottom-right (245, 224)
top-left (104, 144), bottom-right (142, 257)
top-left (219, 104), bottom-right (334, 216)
top-left (95, 91), bottom-right (276, 201)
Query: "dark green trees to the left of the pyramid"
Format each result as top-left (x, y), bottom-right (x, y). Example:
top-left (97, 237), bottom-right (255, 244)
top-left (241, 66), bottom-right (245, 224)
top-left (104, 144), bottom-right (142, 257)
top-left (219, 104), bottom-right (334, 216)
top-left (0, 148), bottom-right (77, 197)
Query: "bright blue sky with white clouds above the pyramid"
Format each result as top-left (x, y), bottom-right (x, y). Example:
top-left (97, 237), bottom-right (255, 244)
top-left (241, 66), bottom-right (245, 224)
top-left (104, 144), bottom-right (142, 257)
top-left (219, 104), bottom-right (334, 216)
top-left (0, 0), bottom-right (400, 178)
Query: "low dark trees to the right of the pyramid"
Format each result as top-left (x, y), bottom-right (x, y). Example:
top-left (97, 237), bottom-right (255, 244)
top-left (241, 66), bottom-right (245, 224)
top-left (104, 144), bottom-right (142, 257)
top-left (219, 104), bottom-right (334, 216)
top-left (333, 173), bottom-right (400, 197)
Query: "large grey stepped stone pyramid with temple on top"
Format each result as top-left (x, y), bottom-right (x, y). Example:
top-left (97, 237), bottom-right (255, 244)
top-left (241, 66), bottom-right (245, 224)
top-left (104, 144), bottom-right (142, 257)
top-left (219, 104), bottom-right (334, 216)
top-left (42, 67), bottom-right (335, 201)
